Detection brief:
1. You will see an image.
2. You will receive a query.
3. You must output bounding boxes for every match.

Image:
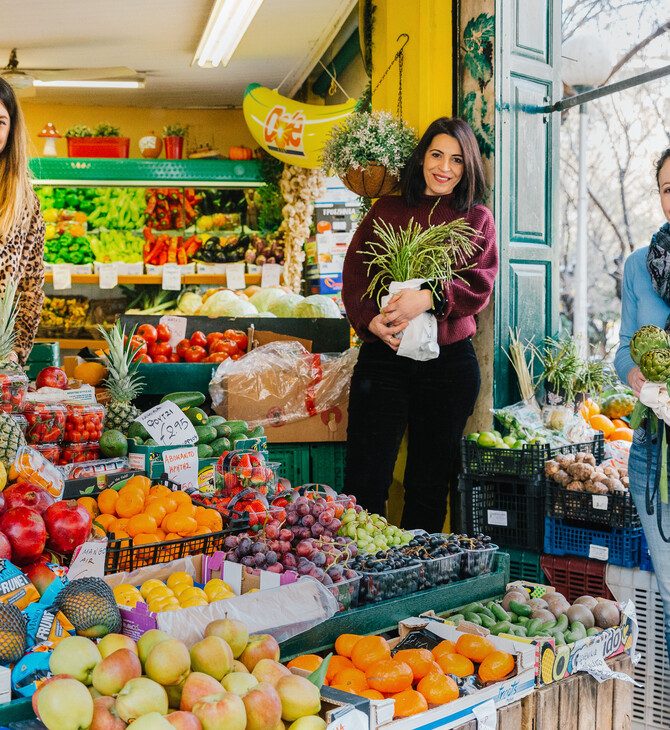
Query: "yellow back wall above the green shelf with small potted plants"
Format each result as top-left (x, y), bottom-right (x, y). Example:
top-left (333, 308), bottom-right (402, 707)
top-left (21, 101), bottom-right (256, 157)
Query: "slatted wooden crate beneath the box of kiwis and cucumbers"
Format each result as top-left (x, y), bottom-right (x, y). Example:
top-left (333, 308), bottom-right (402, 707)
top-left (457, 654), bottom-right (633, 730)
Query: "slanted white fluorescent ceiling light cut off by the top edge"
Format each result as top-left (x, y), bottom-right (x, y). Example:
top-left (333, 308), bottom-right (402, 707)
top-left (191, 0), bottom-right (263, 68)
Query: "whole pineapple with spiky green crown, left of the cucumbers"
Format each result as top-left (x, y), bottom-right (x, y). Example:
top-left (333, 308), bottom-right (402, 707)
top-left (100, 322), bottom-right (142, 435)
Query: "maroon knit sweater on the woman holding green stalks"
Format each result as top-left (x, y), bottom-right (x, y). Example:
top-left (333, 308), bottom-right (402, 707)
top-left (342, 195), bottom-right (498, 345)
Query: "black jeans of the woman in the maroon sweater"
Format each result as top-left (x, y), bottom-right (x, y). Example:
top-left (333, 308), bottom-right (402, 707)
top-left (344, 337), bottom-right (480, 532)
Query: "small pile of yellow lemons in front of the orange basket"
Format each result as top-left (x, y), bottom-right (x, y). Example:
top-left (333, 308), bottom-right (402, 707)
top-left (114, 571), bottom-right (235, 613)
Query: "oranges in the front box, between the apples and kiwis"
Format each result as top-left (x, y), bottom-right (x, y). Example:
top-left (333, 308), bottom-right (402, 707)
top-left (288, 634), bottom-right (515, 718)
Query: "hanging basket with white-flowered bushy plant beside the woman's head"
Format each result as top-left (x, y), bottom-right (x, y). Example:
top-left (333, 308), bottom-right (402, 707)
top-left (320, 111), bottom-right (418, 198)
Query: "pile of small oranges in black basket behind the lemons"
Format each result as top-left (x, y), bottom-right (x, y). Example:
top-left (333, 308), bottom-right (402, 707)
top-left (77, 475), bottom-right (223, 569)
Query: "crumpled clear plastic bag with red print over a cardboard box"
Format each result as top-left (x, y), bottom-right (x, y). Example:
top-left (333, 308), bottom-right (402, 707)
top-left (209, 340), bottom-right (358, 428)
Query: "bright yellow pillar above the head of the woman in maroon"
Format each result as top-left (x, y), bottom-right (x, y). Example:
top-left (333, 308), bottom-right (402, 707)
top-left (372, 0), bottom-right (454, 134)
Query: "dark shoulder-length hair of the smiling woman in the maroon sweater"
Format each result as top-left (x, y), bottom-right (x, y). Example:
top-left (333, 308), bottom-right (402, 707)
top-left (401, 117), bottom-right (486, 210)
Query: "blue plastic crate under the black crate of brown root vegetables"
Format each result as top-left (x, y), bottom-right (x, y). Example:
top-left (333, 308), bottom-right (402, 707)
top-left (544, 517), bottom-right (642, 568)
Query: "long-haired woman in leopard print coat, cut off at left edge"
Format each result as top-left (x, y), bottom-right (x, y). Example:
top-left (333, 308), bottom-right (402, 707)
top-left (0, 79), bottom-right (44, 363)
